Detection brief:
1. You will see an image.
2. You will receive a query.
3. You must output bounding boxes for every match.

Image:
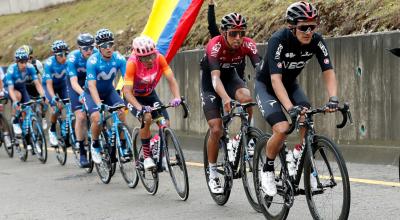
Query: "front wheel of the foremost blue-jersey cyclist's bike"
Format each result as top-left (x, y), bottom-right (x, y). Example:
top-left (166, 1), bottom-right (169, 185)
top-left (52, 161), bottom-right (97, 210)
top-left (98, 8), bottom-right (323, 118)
top-left (118, 123), bottom-right (139, 188)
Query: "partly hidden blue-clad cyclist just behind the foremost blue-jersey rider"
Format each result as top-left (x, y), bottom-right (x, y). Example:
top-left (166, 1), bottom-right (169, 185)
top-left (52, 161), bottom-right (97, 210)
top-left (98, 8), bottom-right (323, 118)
top-left (67, 33), bottom-right (97, 167)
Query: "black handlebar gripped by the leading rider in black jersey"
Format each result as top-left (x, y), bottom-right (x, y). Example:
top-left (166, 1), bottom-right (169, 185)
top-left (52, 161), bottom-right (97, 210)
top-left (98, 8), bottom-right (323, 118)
top-left (286, 102), bottom-right (353, 134)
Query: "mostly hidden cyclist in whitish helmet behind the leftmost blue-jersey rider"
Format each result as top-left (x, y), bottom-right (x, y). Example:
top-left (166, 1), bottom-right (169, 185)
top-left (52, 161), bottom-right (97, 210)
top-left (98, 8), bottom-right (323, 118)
top-left (21, 45), bottom-right (47, 130)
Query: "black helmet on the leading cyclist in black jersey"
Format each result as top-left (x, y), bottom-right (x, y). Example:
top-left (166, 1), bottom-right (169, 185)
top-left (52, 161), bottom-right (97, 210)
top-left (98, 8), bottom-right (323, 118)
top-left (286, 1), bottom-right (318, 25)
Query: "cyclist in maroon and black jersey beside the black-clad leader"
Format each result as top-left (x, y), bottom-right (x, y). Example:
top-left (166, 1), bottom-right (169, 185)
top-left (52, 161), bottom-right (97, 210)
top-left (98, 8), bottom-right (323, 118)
top-left (201, 13), bottom-right (260, 193)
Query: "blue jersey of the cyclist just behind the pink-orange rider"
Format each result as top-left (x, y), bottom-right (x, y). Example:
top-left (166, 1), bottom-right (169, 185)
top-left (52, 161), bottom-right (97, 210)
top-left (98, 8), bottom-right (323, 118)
top-left (86, 52), bottom-right (126, 93)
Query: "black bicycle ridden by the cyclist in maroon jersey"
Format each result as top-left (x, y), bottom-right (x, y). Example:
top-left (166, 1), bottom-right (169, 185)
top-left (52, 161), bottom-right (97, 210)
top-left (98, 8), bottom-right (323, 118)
top-left (203, 100), bottom-right (263, 212)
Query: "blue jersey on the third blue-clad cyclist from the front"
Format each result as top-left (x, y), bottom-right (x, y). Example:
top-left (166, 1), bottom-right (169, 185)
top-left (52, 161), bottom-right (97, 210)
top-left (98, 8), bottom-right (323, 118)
top-left (42, 56), bottom-right (67, 86)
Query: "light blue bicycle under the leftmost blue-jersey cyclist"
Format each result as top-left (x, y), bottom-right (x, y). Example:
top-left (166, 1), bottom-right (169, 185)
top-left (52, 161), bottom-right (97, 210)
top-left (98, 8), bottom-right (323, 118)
top-left (13, 98), bottom-right (47, 163)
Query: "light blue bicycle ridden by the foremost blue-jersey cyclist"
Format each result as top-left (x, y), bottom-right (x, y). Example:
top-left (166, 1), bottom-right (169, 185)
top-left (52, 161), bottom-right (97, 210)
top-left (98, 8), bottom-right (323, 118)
top-left (95, 104), bottom-right (139, 188)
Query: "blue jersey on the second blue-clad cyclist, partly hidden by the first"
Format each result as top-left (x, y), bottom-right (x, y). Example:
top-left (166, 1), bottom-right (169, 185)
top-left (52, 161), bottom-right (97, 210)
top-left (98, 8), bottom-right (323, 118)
top-left (67, 48), bottom-right (98, 86)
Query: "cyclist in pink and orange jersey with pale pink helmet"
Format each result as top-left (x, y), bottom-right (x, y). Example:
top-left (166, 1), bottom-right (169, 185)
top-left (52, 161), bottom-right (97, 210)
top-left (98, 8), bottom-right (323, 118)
top-left (123, 36), bottom-right (181, 169)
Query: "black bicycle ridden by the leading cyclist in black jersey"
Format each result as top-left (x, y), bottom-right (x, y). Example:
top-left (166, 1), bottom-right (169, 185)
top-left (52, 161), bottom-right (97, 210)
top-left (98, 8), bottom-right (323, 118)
top-left (254, 103), bottom-right (352, 219)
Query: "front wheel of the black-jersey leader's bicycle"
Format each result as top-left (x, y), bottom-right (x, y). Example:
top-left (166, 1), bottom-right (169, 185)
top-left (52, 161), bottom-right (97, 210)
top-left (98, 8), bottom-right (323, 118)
top-left (304, 136), bottom-right (350, 219)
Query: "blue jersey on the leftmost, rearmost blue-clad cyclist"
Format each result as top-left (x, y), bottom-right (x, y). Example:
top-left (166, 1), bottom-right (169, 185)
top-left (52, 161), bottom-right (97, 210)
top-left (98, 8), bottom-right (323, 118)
top-left (3, 63), bottom-right (38, 88)
